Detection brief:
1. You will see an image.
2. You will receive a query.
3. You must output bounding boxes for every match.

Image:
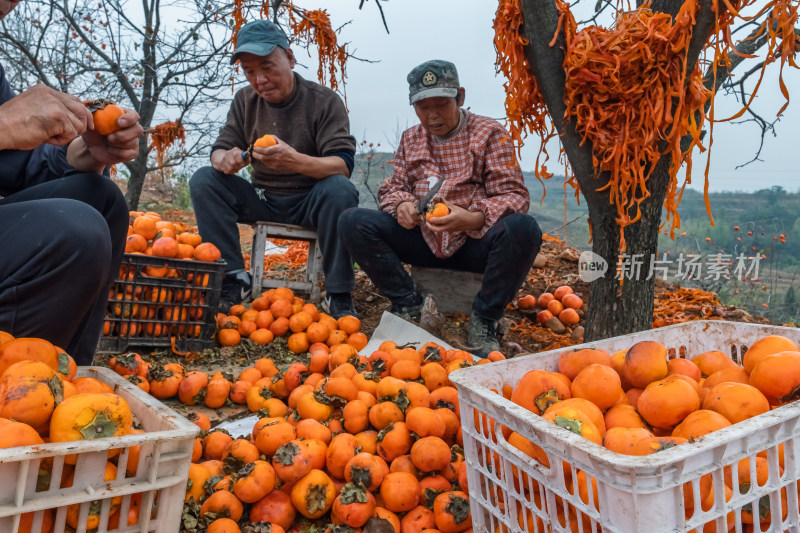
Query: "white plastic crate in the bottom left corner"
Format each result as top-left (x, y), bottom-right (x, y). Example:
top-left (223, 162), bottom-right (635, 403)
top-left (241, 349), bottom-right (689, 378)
top-left (0, 367), bottom-right (199, 533)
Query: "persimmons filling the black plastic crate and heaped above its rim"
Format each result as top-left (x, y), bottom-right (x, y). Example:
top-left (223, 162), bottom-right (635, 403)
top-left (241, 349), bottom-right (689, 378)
top-left (103, 211), bottom-right (220, 338)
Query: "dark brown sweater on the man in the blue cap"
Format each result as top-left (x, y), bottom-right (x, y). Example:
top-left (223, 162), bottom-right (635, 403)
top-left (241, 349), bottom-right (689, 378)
top-left (211, 73), bottom-right (356, 196)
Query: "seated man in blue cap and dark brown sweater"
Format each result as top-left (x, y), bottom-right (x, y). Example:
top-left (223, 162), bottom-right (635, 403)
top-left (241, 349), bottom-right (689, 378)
top-left (189, 20), bottom-right (358, 318)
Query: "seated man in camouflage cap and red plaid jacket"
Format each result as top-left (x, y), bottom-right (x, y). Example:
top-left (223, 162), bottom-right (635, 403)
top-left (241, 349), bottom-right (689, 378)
top-left (339, 60), bottom-right (542, 357)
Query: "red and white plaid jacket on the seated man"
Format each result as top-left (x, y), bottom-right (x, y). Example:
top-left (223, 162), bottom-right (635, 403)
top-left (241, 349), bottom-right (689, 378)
top-left (378, 111), bottom-right (530, 257)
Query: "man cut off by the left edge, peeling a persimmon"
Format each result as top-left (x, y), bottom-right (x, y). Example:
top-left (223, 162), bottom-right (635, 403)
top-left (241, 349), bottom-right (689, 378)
top-left (0, 0), bottom-right (143, 365)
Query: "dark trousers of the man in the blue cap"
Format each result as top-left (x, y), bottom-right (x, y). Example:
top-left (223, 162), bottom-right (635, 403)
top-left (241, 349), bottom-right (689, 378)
top-left (189, 167), bottom-right (358, 293)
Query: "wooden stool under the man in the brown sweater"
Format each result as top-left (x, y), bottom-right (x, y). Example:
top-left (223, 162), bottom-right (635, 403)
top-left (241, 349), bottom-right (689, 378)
top-left (250, 222), bottom-right (322, 303)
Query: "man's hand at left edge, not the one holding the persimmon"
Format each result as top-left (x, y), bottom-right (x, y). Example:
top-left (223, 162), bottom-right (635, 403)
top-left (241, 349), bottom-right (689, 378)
top-left (0, 85), bottom-right (94, 150)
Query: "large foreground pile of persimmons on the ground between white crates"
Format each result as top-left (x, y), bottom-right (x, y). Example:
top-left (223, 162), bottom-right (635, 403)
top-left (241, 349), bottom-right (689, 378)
top-left (174, 341), bottom-right (502, 533)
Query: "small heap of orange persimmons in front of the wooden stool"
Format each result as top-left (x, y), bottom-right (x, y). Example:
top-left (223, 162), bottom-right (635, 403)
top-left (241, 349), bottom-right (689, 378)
top-left (217, 287), bottom-right (367, 354)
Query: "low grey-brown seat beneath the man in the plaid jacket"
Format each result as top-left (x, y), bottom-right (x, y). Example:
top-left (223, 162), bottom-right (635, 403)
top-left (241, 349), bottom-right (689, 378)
top-left (411, 266), bottom-right (483, 315)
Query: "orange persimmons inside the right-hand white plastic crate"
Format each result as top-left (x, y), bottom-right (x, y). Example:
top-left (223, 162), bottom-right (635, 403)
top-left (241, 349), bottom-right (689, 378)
top-left (496, 336), bottom-right (800, 530)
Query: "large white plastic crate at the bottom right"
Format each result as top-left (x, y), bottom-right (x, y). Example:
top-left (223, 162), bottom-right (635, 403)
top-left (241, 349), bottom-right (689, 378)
top-left (450, 321), bottom-right (800, 533)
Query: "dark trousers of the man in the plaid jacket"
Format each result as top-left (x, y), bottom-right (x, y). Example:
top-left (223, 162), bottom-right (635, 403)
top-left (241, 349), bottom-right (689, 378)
top-left (339, 209), bottom-right (542, 320)
